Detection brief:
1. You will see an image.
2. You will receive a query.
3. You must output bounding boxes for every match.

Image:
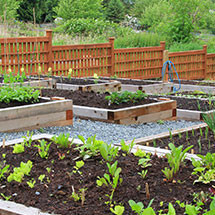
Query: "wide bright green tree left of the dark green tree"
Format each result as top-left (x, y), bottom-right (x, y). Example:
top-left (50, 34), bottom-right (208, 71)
top-left (55, 0), bottom-right (103, 20)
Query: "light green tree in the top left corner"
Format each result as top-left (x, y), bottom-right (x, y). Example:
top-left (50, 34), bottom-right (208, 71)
top-left (0, 0), bottom-right (21, 20)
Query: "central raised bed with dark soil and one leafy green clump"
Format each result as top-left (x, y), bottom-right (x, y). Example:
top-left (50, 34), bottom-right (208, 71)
top-left (42, 89), bottom-right (176, 124)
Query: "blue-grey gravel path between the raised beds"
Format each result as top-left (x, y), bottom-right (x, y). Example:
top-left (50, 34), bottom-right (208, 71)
top-left (0, 118), bottom-right (202, 143)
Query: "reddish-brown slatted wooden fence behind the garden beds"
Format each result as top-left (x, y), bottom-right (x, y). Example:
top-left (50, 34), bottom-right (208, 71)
top-left (0, 30), bottom-right (215, 79)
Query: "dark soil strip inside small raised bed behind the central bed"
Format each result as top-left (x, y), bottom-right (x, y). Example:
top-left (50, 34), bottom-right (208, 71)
top-left (54, 77), bottom-right (104, 85)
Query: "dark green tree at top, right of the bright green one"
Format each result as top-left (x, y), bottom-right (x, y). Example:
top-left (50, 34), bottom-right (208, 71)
top-left (106, 0), bottom-right (125, 23)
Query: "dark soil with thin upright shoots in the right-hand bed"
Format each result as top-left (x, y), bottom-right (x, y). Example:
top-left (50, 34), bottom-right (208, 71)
top-left (146, 129), bottom-right (215, 155)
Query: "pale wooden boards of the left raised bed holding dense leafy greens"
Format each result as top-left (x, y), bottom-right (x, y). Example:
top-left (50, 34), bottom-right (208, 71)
top-left (0, 99), bottom-right (73, 132)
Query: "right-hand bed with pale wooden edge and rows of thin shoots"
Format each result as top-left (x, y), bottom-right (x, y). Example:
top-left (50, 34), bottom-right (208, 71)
top-left (122, 123), bottom-right (215, 157)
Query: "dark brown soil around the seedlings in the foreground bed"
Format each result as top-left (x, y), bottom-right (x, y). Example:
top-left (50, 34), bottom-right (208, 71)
top-left (0, 140), bottom-right (211, 215)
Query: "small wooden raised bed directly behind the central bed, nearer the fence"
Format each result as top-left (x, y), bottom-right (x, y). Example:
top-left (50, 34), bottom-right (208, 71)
top-left (54, 77), bottom-right (121, 92)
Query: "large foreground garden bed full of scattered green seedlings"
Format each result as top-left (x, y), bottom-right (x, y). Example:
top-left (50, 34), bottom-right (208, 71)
top-left (0, 134), bottom-right (214, 215)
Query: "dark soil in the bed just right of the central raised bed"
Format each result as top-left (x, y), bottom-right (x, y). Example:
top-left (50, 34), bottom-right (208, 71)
top-left (151, 95), bottom-right (215, 111)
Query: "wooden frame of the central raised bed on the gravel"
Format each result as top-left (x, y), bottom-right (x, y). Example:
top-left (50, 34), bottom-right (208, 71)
top-left (73, 100), bottom-right (176, 125)
